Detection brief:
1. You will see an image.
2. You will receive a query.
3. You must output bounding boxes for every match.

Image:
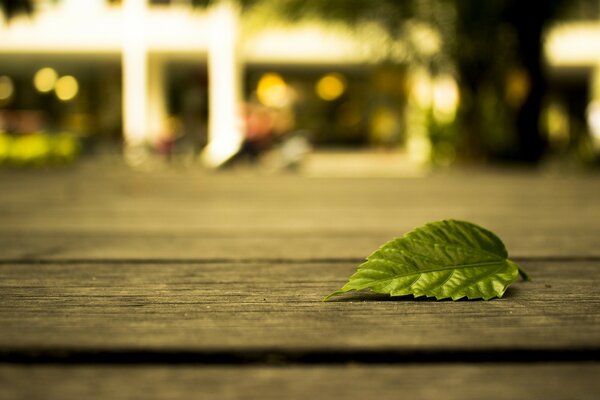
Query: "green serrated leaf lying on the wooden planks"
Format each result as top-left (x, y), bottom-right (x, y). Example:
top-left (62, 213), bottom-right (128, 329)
top-left (323, 220), bottom-right (527, 301)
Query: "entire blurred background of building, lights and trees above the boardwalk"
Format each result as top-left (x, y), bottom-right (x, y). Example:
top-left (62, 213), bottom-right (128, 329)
top-left (0, 0), bottom-right (600, 174)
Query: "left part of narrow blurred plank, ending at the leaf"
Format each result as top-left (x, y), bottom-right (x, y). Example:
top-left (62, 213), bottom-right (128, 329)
top-left (0, 232), bottom-right (386, 261)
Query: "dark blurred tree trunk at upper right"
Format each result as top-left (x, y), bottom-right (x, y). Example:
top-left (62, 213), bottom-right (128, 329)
top-left (453, 0), bottom-right (561, 162)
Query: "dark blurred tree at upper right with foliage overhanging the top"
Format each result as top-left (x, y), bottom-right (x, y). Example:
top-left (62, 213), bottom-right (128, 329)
top-left (0, 0), bottom-right (593, 162)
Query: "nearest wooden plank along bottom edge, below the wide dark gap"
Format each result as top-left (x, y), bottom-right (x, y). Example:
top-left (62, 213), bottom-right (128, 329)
top-left (0, 364), bottom-right (600, 400)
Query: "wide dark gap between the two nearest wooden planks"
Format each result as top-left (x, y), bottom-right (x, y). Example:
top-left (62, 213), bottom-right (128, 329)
top-left (0, 347), bottom-right (600, 365)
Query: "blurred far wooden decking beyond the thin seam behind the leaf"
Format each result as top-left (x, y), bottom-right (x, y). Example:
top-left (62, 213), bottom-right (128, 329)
top-left (0, 169), bottom-right (600, 260)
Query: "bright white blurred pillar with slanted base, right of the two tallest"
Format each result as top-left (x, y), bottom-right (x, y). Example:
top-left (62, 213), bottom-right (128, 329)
top-left (202, 0), bottom-right (243, 168)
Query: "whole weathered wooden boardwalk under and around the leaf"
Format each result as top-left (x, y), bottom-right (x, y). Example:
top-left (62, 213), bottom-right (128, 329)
top-left (0, 165), bottom-right (600, 399)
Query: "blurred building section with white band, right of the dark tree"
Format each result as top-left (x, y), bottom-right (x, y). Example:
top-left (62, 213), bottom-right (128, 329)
top-left (542, 1), bottom-right (600, 162)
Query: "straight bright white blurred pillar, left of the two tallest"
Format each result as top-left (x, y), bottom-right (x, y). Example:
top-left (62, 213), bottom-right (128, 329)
top-left (122, 0), bottom-right (149, 146)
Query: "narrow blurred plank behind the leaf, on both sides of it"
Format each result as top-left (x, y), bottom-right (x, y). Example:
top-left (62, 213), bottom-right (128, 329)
top-left (0, 228), bottom-right (600, 262)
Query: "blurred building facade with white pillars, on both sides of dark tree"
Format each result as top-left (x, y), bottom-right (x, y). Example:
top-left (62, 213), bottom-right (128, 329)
top-left (0, 0), bottom-right (600, 166)
